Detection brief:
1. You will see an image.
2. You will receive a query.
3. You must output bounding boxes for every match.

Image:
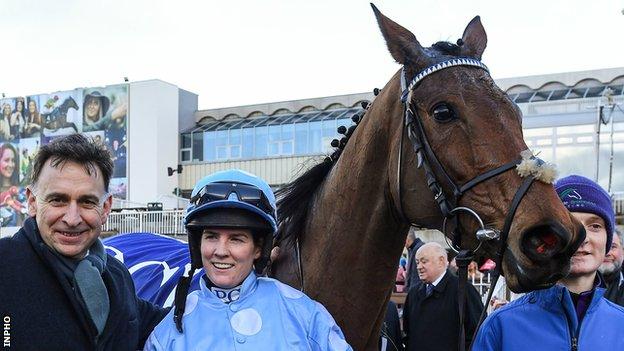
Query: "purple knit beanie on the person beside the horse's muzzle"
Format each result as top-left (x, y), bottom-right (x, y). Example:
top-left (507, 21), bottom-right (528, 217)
top-left (555, 175), bottom-right (615, 254)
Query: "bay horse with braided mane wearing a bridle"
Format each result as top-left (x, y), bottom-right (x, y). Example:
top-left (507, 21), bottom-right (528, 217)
top-left (272, 4), bottom-right (585, 350)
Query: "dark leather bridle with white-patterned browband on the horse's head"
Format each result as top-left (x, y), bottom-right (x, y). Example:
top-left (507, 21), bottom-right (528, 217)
top-left (396, 58), bottom-right (543, 351)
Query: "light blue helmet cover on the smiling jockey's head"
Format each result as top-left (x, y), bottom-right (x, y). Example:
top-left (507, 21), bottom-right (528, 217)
top-left (184, 169), bottom-right (277, 235)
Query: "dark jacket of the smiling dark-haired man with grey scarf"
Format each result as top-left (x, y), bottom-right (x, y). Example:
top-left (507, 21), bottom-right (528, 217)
top-left (0, 218), bottom-right (166, 351)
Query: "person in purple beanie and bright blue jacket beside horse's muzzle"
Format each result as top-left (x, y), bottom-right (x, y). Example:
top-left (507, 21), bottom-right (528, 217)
top-left (472, 175), bottom-right (624, 351)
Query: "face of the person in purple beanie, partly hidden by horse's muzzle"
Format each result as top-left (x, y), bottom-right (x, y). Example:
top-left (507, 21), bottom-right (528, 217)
top-left (570, 212), bottom-right (607, 276)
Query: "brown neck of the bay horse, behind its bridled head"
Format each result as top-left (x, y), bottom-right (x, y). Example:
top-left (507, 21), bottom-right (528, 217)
top-left (301, 82), bottom-right (408, 349)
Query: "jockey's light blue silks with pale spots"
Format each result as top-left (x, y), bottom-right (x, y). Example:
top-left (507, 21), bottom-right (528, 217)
top-left (145, 272), bottom-right (351, 351)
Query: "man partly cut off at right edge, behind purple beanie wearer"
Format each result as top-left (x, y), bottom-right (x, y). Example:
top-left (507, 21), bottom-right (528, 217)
top-left (598, 229), bottom-right (624, 306)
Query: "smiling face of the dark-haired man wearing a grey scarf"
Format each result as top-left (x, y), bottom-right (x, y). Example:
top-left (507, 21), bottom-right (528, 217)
top-left (27, 160), bottom-right (112, 259)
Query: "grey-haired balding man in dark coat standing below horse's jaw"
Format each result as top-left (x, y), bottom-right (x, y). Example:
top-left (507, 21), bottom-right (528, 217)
top-left (403, 243), bottom-right (483, 351)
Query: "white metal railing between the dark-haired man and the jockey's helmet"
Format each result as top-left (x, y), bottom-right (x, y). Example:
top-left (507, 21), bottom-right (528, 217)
top-left (102, 210), bottom-right (186, 235)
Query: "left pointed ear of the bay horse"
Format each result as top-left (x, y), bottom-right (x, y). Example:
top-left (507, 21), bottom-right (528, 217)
top-left (371, 3), bottom-right (423, 65)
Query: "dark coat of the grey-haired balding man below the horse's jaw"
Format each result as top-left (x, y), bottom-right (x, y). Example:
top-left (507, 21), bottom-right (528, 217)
top-left (403, 270), bottom-right (483, 351)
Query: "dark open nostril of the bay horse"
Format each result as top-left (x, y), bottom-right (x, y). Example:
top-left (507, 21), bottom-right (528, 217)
top-left (522, 225), bottom-right (566, 261)
